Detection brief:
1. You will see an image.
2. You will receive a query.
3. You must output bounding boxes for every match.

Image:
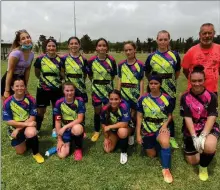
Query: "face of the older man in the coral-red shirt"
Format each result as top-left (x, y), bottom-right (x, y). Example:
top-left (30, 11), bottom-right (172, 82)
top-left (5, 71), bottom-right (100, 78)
top-left (199, 25), bottom-right (215, 47)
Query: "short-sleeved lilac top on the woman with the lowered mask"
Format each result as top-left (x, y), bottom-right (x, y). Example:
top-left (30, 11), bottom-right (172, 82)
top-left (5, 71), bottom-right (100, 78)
top-left (7, 50), bottom-right (34, 75)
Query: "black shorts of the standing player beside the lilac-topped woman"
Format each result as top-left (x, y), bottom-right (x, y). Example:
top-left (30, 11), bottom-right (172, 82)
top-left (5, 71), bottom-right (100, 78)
top-left (36, 88), bottom-right (63, 108)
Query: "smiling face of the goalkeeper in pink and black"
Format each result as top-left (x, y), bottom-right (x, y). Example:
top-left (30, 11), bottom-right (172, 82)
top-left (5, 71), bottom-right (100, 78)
top-left (190, 72), bottom-right (205, 94)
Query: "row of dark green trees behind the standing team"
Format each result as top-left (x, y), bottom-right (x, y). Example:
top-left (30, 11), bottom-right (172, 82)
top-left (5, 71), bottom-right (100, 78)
top-left (34, 34), bottom-right (220, 53)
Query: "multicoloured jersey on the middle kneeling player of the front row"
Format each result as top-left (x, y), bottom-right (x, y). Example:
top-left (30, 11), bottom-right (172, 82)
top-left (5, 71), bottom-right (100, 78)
top-left (100, 101), bottom-right (131, 125)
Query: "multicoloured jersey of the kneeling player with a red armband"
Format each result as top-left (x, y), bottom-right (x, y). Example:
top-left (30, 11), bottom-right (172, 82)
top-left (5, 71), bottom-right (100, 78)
top-left (53, 97), bottom-right (86, 124)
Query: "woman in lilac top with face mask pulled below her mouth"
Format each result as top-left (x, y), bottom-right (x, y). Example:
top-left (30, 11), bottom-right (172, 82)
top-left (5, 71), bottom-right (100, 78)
top-left (1, 30), bottom-right (34, 100)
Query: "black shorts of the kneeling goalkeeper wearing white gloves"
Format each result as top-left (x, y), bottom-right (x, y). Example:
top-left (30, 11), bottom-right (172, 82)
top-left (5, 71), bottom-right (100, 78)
top-left (183, 128), bottom-right (220, 156)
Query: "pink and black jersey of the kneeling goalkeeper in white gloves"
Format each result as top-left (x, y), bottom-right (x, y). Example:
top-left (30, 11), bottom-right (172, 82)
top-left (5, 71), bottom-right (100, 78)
top-left (180, 90), bottom-right (219, 136)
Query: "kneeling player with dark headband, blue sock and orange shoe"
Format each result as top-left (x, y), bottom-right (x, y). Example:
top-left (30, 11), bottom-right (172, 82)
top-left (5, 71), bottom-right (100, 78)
top-left (137, 73), bottom-right (173, 183)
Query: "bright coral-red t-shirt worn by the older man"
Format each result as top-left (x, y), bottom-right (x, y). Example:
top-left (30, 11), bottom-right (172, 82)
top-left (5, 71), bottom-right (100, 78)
top-left (182, 43), bottom-right (220, 92)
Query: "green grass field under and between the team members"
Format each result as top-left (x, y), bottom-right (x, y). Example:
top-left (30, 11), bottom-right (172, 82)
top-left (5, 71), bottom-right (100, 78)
top-left (1, 54), bottom-right (220, 190)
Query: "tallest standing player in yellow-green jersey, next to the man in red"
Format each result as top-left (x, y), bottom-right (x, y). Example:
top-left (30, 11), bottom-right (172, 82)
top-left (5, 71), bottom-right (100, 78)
top-left (145, 30), bottom-right (181, 148)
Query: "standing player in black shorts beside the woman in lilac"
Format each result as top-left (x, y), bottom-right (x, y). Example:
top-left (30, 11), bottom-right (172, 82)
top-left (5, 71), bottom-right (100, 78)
top-left (34, 39), bottom-right (62, 137)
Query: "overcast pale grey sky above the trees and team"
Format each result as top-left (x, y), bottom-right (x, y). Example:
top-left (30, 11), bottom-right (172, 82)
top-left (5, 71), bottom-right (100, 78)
top-left (1, 1), bottom-right (220, 42)
